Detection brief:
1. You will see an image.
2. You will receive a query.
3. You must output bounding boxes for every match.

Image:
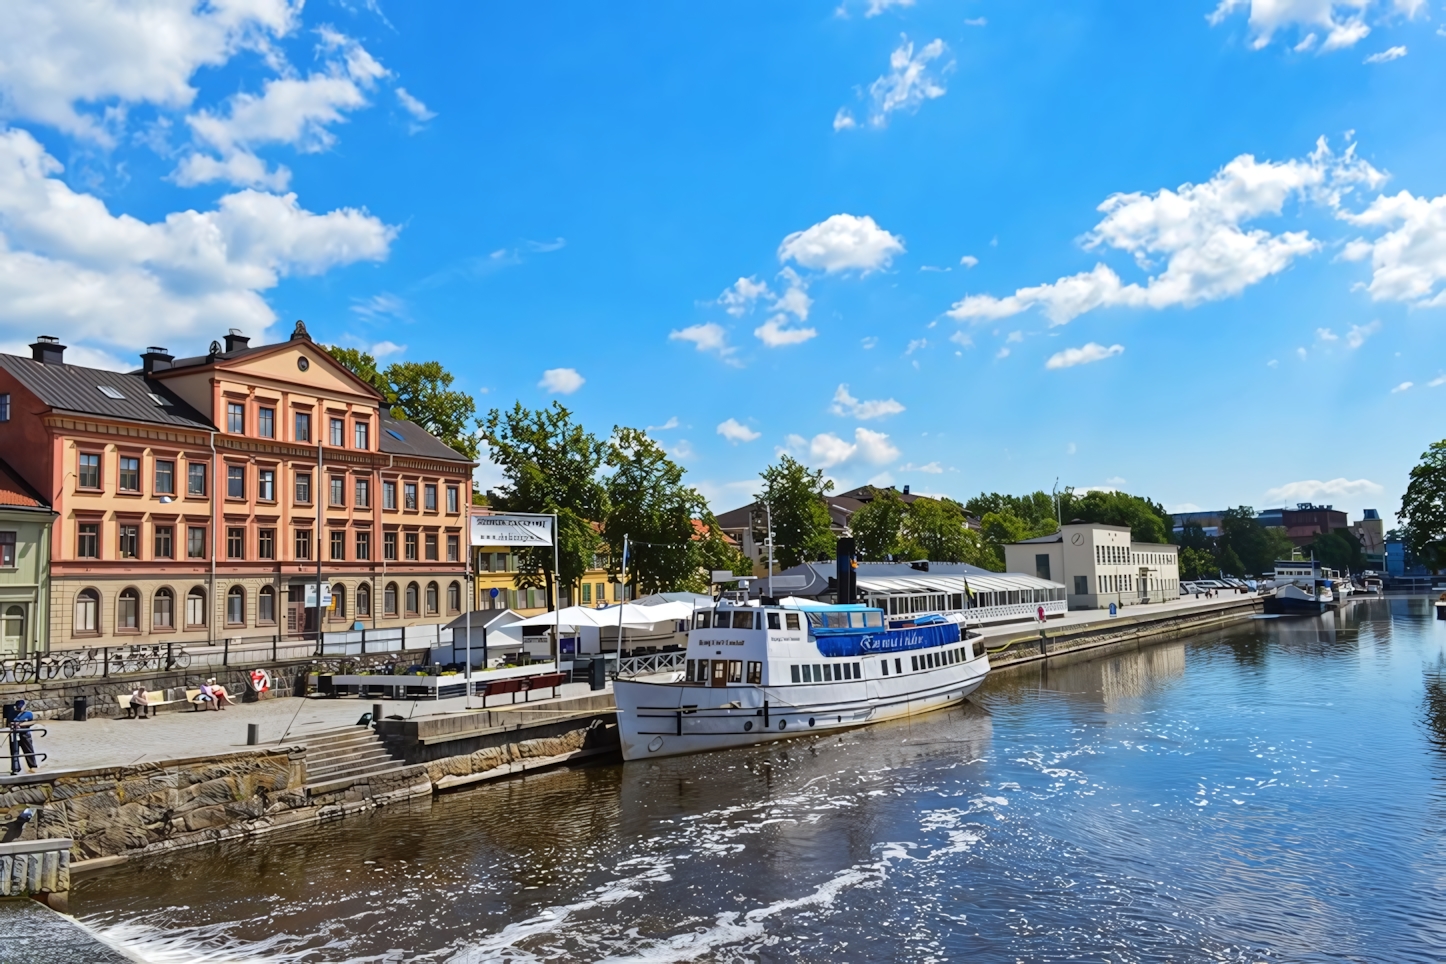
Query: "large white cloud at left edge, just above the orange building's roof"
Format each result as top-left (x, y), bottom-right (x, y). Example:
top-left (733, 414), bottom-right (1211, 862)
top-left (0, 130), bottom-right (396, 353)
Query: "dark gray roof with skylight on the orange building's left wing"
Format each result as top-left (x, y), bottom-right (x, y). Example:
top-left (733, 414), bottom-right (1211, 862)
top-left (0, 354), bottom-right (214, 431)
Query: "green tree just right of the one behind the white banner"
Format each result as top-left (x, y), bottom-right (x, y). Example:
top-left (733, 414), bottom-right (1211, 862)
top-left (603, 428), bottom-right (707, 595)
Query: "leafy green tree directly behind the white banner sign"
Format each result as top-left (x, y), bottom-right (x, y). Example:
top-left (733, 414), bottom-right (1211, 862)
top-left (480, 402), bottom-right (607, 598)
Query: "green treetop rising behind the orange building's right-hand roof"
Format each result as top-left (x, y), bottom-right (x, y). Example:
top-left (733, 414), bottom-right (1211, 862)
top-left (327, 345), bottom-right (479, 460)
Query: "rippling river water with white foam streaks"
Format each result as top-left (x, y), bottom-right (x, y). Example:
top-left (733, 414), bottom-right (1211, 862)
top-left (72, 598), bottom-right (1446, 964)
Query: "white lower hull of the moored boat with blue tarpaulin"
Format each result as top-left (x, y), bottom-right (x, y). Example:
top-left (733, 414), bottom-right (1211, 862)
top-left (613, 658), bottom-right (989, 760)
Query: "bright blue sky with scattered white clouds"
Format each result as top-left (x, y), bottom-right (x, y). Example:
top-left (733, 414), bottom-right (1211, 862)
top-left (0, 0), bottom-right (1446, 520)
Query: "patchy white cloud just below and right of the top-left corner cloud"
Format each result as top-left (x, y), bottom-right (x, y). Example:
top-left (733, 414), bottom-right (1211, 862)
top-left (175, 29), bottom-right (388, 188)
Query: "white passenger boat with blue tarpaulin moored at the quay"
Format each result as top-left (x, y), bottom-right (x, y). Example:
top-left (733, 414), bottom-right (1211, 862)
top-left (613, 600), bottom-right (989, 760)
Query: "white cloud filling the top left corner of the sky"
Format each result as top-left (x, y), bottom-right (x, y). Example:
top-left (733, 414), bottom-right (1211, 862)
top-left (0, 0), bottom-right (301, 145)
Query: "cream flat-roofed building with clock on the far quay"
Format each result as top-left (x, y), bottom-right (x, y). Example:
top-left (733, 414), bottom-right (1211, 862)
top-left (1004, 522), bottom-right (1180, 608)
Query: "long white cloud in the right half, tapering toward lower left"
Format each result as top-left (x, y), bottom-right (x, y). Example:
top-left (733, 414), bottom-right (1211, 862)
top-left (949, 139), bottom-right (1384, 325)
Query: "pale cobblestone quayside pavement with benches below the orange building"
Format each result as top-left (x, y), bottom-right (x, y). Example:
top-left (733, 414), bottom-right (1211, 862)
top-left (14, 682), bottom-right (607, 774)
